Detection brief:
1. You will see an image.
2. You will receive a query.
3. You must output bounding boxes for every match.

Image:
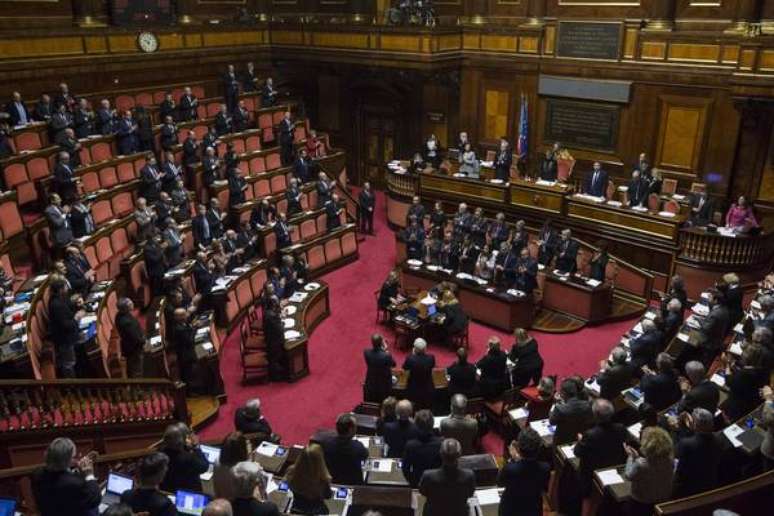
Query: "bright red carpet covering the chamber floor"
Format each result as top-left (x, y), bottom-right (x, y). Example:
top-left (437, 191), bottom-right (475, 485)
top-left (200, 189), bottom-right (632, 454)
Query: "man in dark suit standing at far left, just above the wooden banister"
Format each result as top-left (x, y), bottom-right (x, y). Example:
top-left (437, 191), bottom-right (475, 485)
top-left (48, 277), bottom-right (85, 378)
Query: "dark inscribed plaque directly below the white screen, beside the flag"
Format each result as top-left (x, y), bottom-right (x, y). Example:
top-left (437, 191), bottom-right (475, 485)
top-left (544, 99), bottom-right (619, 151)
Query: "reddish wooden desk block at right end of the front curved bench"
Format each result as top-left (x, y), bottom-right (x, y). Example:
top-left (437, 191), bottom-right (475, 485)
top-left (543, 272), bottom-right (613, 322)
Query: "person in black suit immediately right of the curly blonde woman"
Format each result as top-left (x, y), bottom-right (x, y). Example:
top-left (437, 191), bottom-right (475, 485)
top-left (673, 408), bottom-right (722, 498)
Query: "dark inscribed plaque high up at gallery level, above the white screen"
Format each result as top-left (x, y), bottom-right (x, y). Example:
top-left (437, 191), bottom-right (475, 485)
top-left (556, 21), bottom-right (621, 59)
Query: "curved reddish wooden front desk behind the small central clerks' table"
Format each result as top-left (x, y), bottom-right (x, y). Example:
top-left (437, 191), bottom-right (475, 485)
top-left (401, 263), bottom-right (535, 332)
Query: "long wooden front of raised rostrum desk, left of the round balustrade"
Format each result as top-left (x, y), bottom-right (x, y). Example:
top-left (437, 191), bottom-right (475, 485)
top-left (567, 196), bottom-right (685, 242)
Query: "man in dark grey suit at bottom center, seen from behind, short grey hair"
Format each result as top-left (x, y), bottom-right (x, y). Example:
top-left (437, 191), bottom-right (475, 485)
top-left (419, 439), bottom-right (476, 516)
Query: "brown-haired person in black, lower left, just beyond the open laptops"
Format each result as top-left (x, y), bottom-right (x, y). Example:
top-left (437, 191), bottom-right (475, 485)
top-left (160, 423), bottom-right (210, 493)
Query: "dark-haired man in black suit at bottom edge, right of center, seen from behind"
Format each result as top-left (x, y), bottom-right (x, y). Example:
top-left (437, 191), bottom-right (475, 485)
top-left (497, 427), bottom-right (551, 516)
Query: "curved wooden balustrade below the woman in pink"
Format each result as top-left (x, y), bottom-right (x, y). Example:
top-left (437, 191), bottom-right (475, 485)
top-left (678, 228), bottom-right (774, 267)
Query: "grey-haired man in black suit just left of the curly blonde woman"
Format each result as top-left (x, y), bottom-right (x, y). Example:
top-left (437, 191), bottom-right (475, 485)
top-left (573, 398), bottom-right (631, 497)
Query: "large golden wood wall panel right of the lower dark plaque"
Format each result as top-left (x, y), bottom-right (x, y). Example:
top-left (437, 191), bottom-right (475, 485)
top-left (656, 96), bottom-right (709, 175)
